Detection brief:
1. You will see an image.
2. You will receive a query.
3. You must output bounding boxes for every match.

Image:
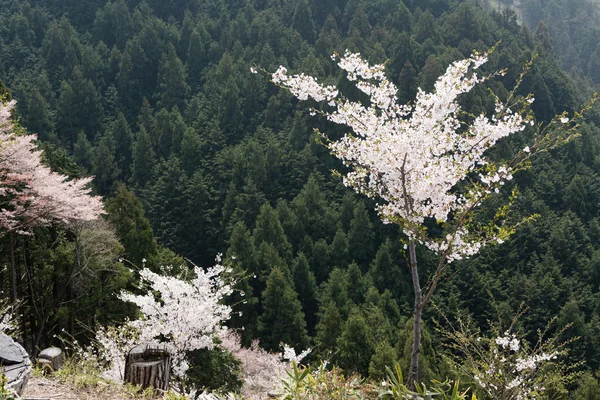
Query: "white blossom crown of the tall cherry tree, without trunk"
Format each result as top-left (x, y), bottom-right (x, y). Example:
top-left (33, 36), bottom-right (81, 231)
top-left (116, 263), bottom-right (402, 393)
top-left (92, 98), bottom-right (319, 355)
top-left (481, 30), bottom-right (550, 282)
top-left (272, 52), bottom-right (531, 261)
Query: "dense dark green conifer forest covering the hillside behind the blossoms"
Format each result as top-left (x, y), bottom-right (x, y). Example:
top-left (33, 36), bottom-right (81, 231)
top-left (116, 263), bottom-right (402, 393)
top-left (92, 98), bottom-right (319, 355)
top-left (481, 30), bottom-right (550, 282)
top-left (0, 0), bottom-right (600, 399)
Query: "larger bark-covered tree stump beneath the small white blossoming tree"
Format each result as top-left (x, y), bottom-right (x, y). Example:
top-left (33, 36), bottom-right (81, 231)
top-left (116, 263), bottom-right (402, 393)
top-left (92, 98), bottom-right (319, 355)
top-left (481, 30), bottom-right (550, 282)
top-left (124, 344), bottom-right (171, 392)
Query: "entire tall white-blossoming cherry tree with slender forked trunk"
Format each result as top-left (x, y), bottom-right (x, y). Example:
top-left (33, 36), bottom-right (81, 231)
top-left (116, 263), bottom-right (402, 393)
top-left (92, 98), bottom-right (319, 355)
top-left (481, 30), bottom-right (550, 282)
top-left (266, 52), bottom-right (576, 388)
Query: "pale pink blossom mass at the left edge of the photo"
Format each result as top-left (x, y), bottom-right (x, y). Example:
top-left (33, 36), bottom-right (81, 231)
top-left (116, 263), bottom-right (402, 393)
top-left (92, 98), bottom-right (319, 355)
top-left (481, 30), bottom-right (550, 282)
top-left (0, 101), bottom-right (103, 233)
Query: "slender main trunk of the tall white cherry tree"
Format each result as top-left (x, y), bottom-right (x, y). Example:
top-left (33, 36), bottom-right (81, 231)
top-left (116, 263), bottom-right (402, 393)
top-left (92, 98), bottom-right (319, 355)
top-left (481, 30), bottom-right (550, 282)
top-left (407, 240), bottom-right (423, 390)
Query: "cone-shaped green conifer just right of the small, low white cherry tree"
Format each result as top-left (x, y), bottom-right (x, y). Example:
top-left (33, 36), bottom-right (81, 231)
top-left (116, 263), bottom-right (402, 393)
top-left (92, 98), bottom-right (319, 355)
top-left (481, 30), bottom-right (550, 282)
top-left (258, 268), bottom-right (308, 351)
